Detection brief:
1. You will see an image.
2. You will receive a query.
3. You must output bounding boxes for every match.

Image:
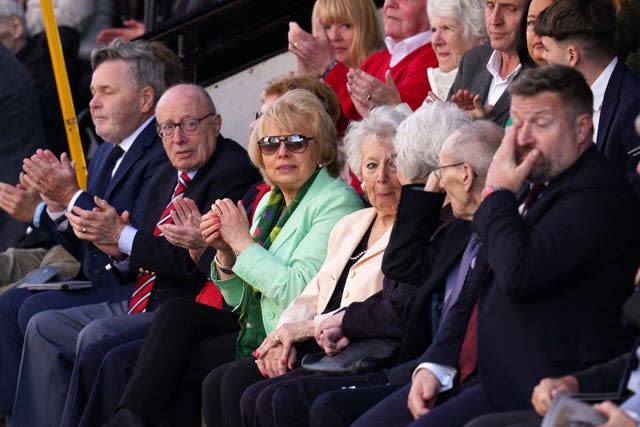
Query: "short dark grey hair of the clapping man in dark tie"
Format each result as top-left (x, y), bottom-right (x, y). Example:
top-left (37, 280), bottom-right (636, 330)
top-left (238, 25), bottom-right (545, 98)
top-left (91, 38), bottom-right (165, 102)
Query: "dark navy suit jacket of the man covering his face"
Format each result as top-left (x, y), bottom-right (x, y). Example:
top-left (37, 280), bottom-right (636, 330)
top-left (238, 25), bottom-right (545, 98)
top-left (420, 147), bottom-right (640, 411)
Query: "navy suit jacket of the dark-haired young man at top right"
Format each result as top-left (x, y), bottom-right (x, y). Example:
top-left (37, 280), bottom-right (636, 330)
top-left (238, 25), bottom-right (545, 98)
top-left (596, 60), bottom-right (640, 194)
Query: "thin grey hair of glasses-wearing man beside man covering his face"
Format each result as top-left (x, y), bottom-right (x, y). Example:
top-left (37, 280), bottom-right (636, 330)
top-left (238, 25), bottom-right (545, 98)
top-left (443, 120), bottom-right (504, 179)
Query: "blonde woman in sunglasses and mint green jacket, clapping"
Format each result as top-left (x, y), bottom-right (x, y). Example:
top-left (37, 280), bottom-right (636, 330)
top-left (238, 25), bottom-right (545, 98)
top-left (107, 90), bottom-right (361, 427)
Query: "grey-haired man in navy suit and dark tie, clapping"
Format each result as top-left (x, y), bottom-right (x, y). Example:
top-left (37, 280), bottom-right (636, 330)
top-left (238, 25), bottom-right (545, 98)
top-left (0, 41), bottom-right (167, 422)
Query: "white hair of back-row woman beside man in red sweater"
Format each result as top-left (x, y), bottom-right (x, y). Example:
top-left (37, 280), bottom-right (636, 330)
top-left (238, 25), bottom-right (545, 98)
top-left (427, 0), bottom-right (487, 45)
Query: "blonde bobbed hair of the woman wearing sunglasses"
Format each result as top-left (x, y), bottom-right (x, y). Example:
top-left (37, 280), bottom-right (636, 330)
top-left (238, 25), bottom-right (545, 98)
top-left (248, 89), bottom-right (340, 183)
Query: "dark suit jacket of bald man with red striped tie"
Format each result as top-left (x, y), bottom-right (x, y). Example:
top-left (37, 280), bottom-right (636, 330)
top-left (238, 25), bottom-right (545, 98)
top-left (129, 136), bottom-right (261, 304)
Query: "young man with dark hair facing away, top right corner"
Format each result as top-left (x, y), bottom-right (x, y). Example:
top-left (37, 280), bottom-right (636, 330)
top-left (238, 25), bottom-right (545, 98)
top-left (535, 0), bottom-right (640, 194)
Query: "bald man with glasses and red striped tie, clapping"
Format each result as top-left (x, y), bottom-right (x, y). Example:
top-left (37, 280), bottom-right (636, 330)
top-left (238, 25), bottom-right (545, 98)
top-left (12, 84), bottom-right (260, 425)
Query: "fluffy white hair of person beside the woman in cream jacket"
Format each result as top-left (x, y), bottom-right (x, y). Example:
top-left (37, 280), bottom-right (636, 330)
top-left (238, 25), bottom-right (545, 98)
top-left (393, 101), bottom-right (471, 182)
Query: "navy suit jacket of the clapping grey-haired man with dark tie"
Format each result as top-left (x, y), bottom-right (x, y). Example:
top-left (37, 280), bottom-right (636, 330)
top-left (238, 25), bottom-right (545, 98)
top-left (40, 120), bottom-right (167, 298)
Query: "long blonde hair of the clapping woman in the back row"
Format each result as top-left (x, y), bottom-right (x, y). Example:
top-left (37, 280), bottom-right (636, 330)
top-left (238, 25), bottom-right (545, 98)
top-left (311, 0), bottom-right (383, 67)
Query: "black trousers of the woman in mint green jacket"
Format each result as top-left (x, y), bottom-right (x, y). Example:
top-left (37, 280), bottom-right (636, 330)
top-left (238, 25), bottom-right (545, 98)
top-left (119, 299), bottom-right (239, 426)
